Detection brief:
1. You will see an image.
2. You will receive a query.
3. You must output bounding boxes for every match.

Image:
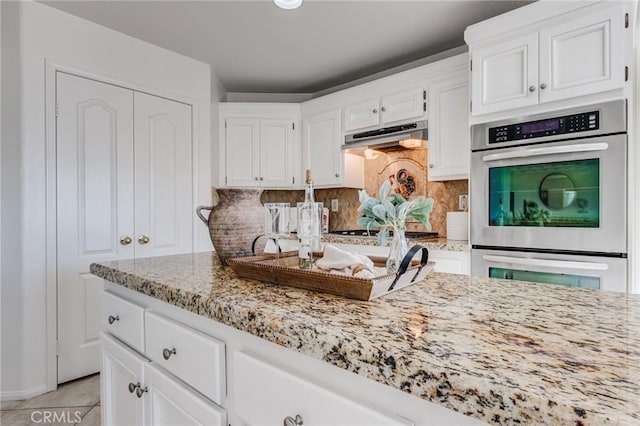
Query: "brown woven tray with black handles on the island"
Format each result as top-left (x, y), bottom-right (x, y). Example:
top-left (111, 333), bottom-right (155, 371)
top-left (227, 249), bottom-right (435, 300)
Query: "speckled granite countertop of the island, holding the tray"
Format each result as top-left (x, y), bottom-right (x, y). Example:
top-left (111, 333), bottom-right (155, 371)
top-left (91, 253), bottom-right (640, 425)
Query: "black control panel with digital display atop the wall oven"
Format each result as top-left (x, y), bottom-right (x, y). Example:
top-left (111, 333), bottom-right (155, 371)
top-left (489, 111), bottom-right (600, 144)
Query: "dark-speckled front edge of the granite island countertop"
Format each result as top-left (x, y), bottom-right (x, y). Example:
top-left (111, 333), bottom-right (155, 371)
top-left (90, 255), bottom-right (639, 424)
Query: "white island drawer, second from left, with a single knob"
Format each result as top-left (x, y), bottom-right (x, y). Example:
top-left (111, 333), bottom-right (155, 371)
top-left (145, 312), bottom-right (225, 404)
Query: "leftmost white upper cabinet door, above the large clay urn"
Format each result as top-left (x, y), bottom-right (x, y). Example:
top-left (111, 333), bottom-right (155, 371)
top-left (225, 118), bottom-right (260, 187)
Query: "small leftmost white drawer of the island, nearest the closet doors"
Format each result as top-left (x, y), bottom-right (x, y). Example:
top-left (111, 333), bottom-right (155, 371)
top-left (100, 291), bottom-right (144, 353)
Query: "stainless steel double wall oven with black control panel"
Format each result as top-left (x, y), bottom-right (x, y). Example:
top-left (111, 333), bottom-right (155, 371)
top-left (471, 100), bottom-right (628, 291)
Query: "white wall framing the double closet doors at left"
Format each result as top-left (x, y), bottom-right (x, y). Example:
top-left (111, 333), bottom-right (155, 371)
top-left (2, 2), bottom-right (211, 399)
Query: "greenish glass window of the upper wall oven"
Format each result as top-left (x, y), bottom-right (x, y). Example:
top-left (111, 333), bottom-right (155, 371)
top-left (489, 158), bottom-right (600, 228)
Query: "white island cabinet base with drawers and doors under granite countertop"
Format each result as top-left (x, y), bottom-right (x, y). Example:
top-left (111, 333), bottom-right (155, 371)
top-left (100, 282), bottom-right (481, 426)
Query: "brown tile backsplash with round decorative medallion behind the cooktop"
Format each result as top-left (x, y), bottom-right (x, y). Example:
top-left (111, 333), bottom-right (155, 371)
top-left (261, 149), bottom-right (469, 237)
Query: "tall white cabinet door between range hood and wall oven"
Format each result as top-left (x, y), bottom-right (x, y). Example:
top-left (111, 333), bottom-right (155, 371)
top-left (427, 76), bottom-right (470, 181)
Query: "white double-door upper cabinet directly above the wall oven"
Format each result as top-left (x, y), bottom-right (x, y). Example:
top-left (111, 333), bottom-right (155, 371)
top-left (467, 3), bottom-right (626, 115)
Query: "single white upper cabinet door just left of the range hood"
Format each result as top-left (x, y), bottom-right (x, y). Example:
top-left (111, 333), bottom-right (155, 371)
top-left (303, 109), bottom-right (343, 186)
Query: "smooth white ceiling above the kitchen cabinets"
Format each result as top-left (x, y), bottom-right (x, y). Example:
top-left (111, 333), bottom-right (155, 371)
top-left (38, 0), bottom-right (528, 93)
